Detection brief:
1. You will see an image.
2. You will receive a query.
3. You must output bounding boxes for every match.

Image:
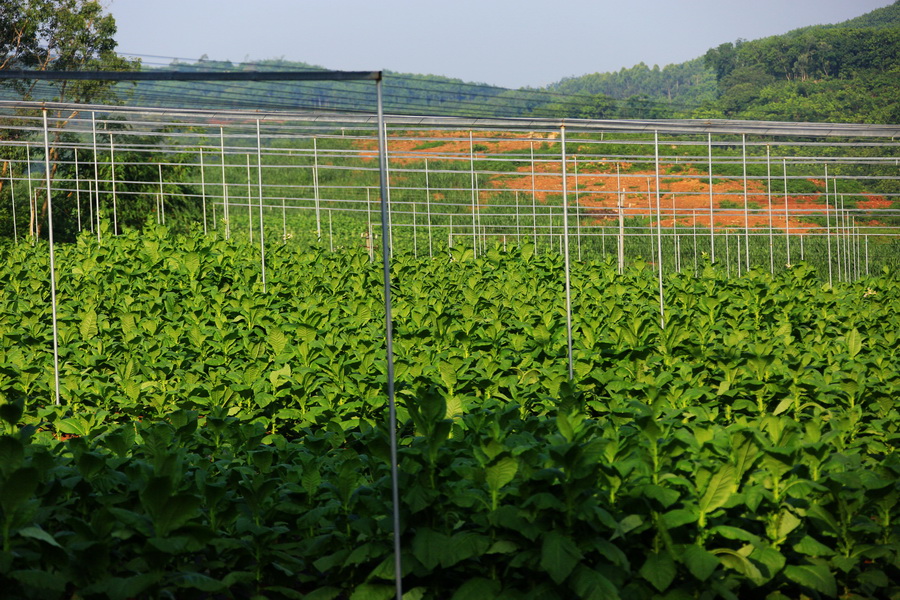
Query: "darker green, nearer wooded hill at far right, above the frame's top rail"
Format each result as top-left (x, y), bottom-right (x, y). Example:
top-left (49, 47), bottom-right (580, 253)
top-left (704, 2), bottom-right (900, 123)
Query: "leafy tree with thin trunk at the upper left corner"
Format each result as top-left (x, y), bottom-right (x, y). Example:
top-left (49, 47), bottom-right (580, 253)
top-left (0, 0), bottom-right (140, 236)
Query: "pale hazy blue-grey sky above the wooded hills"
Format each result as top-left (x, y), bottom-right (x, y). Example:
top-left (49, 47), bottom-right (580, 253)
top-left (107, 0), bottom-right (893, 87)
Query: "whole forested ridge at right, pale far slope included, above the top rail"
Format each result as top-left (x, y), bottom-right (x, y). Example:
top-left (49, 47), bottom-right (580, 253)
top-left (536, 2), bottom-right (900, 123)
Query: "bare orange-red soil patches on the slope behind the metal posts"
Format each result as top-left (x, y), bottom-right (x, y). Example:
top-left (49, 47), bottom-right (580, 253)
top-left (356, 131), bottom-right (856, 233)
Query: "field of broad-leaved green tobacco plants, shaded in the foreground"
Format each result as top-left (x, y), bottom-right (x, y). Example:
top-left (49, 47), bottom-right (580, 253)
top-left (0, 226), bottom-right (900, 600)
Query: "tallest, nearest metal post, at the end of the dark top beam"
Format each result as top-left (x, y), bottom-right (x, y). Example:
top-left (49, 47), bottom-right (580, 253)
top-left (375, 77), bottom-right (403, 600)
